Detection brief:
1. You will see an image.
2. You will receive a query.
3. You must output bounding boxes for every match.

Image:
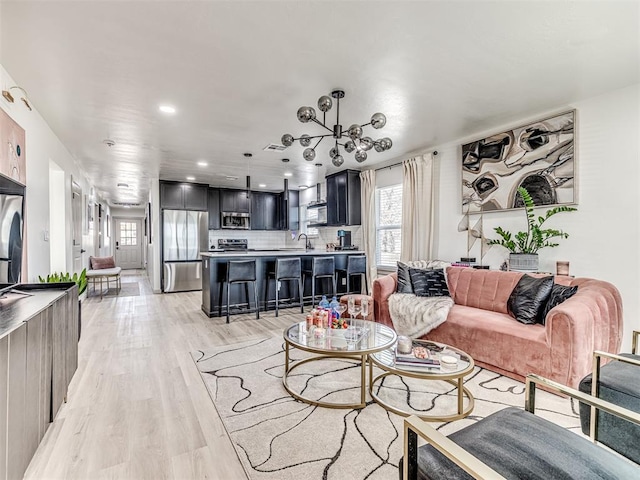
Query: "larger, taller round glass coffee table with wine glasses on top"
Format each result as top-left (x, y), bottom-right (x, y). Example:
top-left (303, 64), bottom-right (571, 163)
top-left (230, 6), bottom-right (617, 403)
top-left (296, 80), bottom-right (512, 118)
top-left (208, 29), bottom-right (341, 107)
top-left (282, 320), bottom-right (397, 408)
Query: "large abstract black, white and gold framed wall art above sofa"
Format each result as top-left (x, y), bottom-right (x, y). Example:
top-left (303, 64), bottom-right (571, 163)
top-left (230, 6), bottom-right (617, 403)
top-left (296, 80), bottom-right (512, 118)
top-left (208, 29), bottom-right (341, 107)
top-left (462, 110), bottom-right (577, 214)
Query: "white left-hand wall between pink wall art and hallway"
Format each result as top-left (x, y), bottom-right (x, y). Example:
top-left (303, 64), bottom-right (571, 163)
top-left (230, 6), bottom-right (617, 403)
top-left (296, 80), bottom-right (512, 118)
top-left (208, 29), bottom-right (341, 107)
top-left (0, 64), bottom-right (98, 282)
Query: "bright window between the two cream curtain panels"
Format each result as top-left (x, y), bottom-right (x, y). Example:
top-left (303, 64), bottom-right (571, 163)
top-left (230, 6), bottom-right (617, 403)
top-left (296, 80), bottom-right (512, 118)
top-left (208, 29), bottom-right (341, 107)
top-left (376, 184), bottom-right (402, 267)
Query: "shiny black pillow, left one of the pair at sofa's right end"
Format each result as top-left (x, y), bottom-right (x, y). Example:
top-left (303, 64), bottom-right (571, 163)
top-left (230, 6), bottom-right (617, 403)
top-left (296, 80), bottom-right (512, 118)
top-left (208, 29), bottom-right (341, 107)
top-left (507, 275), bottom-right (553, 325)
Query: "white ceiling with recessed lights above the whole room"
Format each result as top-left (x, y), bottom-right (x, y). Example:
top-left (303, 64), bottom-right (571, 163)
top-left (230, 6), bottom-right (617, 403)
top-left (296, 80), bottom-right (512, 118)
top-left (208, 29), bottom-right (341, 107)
top-left (0, 0), bottom-right (640, 203)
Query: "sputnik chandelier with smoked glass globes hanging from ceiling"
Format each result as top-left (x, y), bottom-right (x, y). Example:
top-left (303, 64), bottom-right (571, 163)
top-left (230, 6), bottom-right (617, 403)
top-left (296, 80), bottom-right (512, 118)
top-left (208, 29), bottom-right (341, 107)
top-left (281, 90), bottom-right (393, 167)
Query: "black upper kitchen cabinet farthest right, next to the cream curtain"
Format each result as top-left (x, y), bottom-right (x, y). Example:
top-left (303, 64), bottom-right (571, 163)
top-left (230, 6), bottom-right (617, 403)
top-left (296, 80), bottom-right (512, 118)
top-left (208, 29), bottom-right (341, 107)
top-left (326, 170), bottom-right (361, 227)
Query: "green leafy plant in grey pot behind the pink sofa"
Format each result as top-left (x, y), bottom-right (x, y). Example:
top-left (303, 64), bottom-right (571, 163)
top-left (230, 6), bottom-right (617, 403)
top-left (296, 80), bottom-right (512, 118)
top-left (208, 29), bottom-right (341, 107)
top-left (487, 187), bottom-right (577, 271)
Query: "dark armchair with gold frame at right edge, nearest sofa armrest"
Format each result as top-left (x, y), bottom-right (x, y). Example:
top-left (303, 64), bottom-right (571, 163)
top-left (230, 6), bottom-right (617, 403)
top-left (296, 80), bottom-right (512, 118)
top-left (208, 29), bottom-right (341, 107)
top-left (579, 331), bottom-right (640, 463)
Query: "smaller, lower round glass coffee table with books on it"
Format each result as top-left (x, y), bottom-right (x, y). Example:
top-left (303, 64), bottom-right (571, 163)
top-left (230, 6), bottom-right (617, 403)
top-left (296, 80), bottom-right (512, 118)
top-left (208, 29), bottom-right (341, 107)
top-left (369, 340), bottom-right (475, 422)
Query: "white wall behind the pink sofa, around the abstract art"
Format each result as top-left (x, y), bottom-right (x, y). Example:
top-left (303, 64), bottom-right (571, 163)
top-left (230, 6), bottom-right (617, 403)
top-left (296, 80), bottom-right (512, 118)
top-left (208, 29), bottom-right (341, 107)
top-left (378, 85), bottom-right (640, 351)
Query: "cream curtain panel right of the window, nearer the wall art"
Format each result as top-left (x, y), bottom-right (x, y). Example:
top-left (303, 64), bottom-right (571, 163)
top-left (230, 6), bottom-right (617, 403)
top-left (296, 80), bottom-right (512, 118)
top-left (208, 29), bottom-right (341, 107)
top-left (400, 153), bottom-right (435, 261)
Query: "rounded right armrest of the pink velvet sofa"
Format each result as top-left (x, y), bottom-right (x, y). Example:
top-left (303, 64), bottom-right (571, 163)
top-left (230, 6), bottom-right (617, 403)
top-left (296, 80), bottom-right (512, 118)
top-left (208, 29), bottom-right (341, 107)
top-left (545, 278), bottom-right (622, 388)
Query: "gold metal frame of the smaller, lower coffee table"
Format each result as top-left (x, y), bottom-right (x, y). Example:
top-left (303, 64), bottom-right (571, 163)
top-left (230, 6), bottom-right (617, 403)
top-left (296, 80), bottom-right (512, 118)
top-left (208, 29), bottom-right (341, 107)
top-left (369, 344), bottom-right (475, 422)
